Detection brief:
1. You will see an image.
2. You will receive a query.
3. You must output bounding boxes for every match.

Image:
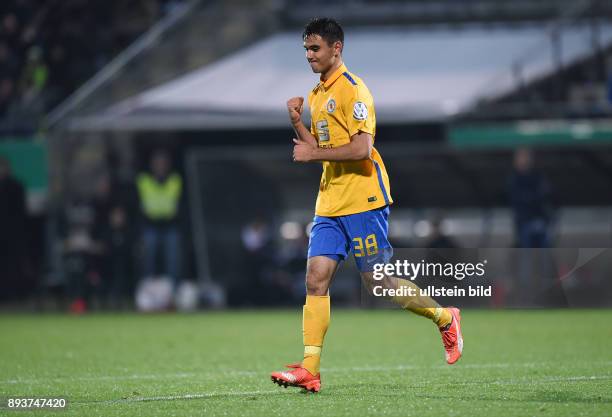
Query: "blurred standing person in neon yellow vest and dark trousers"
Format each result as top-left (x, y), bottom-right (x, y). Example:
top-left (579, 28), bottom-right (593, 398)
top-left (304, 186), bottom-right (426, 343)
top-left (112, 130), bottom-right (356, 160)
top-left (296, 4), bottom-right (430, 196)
top-left (136, 150), bottom-right (183, 288)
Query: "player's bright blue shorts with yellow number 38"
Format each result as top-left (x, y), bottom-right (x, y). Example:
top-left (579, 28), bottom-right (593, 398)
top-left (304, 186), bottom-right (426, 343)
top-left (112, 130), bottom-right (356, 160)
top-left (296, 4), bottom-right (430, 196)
top-left (308, 206), bottom-right (393, 272)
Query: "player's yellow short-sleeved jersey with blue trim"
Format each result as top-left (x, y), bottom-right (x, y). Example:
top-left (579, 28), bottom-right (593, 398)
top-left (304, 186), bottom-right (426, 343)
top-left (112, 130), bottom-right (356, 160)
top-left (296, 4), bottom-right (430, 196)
top-left (308, 65), bottom-right (393, 217)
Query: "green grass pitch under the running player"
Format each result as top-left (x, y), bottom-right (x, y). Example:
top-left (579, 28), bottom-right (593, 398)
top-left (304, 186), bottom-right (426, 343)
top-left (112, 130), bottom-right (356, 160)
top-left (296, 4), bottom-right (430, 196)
top-left (0, 309), bottom-right (612, 417)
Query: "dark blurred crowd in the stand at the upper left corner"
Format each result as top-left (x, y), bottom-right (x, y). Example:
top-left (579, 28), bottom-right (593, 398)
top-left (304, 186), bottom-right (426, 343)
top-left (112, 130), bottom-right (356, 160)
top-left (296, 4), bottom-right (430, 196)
top-left (0, 0), bottom-right (181, 134)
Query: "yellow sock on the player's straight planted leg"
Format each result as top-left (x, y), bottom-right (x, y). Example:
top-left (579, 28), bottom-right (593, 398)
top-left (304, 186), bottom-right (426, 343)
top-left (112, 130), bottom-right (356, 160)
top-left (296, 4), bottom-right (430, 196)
top-left (302, 295), bottom-right (330, 375)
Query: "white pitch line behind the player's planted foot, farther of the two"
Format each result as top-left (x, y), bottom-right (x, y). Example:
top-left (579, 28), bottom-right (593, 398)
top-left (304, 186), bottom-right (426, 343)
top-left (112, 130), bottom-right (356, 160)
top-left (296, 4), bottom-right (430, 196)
top-left (0, 362), bottom-right (612, 385)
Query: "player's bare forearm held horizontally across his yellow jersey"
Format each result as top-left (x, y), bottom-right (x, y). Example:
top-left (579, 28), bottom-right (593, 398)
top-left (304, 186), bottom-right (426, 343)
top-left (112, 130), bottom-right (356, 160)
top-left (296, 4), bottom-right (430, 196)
top-left (293, 132), bottom-right (373, 162)
